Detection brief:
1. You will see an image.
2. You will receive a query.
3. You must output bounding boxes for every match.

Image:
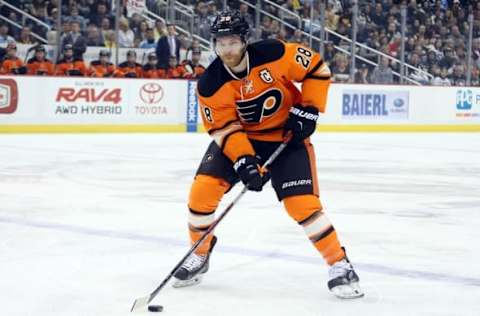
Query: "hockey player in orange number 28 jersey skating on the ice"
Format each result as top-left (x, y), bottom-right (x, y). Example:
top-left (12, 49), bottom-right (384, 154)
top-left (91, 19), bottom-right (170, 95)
top-left (174, 11), bottom-right (363, 298)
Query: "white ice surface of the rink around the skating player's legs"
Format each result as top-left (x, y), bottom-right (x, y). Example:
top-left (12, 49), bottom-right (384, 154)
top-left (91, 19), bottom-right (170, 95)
top-left (0, 133), bottom-right (480, 316)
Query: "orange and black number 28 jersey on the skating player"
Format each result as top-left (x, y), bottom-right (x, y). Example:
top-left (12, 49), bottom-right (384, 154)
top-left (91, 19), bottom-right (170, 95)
top-left (197, 40), bottom-right (331, 161)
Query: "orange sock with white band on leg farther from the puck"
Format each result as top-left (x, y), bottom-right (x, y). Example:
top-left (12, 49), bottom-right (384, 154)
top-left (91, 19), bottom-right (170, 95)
top-left (283, 194), bottom-right (345, 265)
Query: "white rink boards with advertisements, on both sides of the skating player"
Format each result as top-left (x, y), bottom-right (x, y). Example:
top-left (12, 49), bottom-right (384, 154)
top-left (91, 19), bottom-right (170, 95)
top-left (0, 76), bottom-right (480, 132)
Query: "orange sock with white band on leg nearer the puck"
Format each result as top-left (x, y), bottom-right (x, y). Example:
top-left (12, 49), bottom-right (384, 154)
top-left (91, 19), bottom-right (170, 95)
top-left (188, 175), bottom-right (230, 255)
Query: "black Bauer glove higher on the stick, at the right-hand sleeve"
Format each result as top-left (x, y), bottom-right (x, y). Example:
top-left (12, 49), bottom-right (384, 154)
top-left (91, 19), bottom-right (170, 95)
top-left (283, 104), bottom-right (318, 143)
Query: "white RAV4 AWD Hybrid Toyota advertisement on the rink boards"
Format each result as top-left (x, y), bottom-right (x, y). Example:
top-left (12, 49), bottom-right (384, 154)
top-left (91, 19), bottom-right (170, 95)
top-left (0, 77), bottom-right (187, 131)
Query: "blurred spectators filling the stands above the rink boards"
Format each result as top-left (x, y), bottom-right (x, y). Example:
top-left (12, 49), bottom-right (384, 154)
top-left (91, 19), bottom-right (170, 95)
top-left (0, 0), bottom-right (480, 86)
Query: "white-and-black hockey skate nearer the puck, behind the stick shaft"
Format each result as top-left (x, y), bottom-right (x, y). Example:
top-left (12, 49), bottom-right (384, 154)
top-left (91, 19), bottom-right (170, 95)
top-left (173, 236), bottom-right (217, 288)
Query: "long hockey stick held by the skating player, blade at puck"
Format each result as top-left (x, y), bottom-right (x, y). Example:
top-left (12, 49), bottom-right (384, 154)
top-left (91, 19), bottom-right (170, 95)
top-left (130, 134), bottom-right (291, 312)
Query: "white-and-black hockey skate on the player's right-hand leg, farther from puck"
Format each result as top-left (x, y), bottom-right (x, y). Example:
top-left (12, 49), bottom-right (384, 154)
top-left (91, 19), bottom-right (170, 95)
top-left (328, 257), bottom-right (365, 299)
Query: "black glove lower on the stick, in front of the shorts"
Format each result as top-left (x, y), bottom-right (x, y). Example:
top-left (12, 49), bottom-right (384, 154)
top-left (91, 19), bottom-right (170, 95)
top-left (233, 155), bottom-right (270, 192)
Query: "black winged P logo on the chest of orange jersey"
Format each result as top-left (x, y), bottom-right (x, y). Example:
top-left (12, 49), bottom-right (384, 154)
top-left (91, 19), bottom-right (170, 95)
top-left (237, 89), bottom-right (283, 123)
